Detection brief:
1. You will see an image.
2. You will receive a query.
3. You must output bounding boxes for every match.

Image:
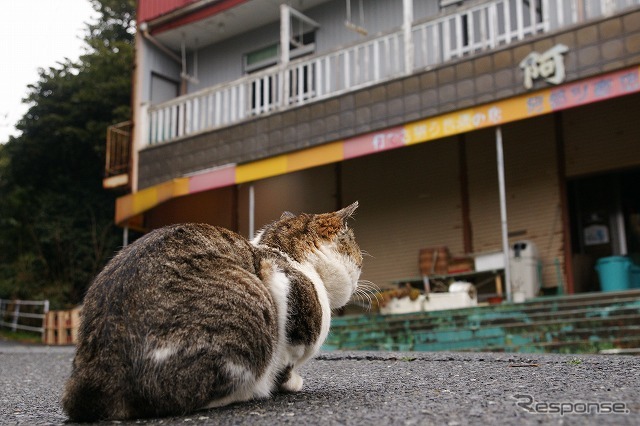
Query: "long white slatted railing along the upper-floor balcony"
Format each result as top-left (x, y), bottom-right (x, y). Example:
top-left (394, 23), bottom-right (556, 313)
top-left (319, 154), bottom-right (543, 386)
top-left (148, 0), bottom-right (640, 144)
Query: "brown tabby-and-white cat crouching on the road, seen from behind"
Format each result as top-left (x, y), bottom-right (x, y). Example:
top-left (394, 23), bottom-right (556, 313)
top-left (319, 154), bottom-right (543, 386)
top-left (62, 202), bottom-right (362, 421)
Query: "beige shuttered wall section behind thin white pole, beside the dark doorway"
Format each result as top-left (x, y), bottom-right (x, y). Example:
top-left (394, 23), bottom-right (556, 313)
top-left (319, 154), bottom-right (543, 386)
top-left (466, 115), bottom-right (566, 287)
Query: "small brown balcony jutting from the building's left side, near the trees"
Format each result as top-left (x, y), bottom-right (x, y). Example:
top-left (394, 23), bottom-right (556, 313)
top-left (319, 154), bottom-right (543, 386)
top-left (102, 121), bottom-right (132, 189)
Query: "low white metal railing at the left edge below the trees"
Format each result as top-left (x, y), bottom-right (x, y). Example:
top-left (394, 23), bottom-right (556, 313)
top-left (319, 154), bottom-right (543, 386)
top-left (0, 299), bottom-right (49, 336)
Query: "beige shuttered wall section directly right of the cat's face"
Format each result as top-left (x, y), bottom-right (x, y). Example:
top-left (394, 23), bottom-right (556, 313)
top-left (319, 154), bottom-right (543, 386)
top-left (343, 138), bottom-right (463, 287)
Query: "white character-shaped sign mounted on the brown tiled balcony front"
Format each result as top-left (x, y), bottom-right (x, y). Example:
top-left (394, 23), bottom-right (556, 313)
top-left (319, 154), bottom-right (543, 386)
top-left (520, 44), bottom-right (569, 89)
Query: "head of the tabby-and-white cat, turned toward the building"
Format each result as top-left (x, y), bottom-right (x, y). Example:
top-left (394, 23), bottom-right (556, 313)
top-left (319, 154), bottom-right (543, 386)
top-left (253, 201), bottom-right (362, 309)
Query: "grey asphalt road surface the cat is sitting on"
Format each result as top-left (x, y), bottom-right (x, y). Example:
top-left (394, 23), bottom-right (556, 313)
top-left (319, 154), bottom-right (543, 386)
top-left (0, 342), bottom-right (640, 426)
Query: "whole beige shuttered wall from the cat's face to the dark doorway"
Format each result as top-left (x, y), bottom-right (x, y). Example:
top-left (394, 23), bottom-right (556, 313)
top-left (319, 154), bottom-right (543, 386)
top-left (343, 116), bottom-right (564, 287)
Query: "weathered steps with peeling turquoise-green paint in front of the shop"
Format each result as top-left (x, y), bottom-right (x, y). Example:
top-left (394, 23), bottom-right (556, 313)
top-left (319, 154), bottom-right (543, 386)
top-left (324, 290), bottom-right (640, 353)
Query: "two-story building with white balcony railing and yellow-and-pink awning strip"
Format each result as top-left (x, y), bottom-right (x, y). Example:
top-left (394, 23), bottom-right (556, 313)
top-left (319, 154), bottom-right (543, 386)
top-left (105, 0), bottom-right (640, 300)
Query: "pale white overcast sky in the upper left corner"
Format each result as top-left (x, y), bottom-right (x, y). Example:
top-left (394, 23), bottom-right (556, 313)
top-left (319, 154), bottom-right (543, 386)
top-left (0, 0), bottom-right (97, 143)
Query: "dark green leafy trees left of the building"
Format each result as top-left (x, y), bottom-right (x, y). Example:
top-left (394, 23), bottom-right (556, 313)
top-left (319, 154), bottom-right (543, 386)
top-left (0, 0), bottom-right (135, 306)
